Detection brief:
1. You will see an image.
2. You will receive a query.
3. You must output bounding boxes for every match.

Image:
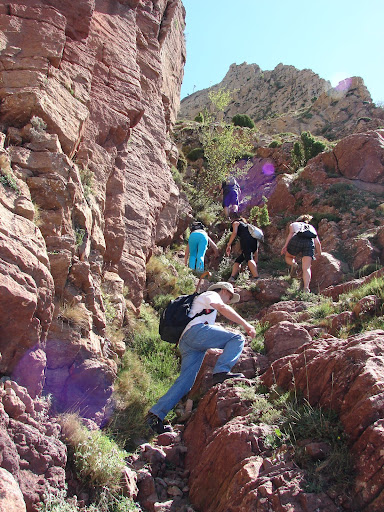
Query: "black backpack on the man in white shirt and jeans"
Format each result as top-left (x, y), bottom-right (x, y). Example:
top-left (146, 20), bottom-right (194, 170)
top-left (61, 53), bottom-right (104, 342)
top-left (159, 292), bottom-right (212, 344)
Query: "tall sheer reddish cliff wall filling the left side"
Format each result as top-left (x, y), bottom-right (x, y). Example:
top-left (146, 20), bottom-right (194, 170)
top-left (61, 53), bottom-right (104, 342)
top-left (0, 0), bottom-right (185, 422)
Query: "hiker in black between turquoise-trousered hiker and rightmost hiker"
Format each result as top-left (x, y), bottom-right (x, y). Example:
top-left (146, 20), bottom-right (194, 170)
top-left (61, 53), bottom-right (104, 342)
top-left (225, 217), bottom-right (259, 283)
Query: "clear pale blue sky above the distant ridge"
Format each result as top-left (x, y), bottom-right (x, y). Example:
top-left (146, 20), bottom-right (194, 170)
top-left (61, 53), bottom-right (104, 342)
top-left (181, 0), bottom-right (384, 102)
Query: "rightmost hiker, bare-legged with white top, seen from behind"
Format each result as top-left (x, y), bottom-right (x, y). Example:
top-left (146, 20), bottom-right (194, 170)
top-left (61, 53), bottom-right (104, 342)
top-left (281, 215), bottom-right (321, 292)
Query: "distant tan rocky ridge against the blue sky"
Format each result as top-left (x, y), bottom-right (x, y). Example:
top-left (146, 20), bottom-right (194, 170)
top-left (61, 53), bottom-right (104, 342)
top-left (179, 63), bottom-right (384, 139)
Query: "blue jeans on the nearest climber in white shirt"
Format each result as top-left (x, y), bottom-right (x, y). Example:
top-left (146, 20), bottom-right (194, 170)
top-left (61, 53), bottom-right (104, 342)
top-left (150, 324), bottom-right (245, 420)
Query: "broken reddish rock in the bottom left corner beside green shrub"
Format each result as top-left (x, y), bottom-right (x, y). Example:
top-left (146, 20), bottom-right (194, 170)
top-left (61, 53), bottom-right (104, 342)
top-left (0, 380), bottom-right (67, 512)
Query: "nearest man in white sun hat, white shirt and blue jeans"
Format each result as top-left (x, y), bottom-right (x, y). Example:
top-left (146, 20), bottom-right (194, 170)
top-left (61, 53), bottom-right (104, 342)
top-left (146, 281), bottom-right (256, 434)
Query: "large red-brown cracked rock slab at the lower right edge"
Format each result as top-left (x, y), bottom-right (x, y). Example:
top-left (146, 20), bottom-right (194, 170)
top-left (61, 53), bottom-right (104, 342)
top-left (262, 330), bottom-right (384, 512)
